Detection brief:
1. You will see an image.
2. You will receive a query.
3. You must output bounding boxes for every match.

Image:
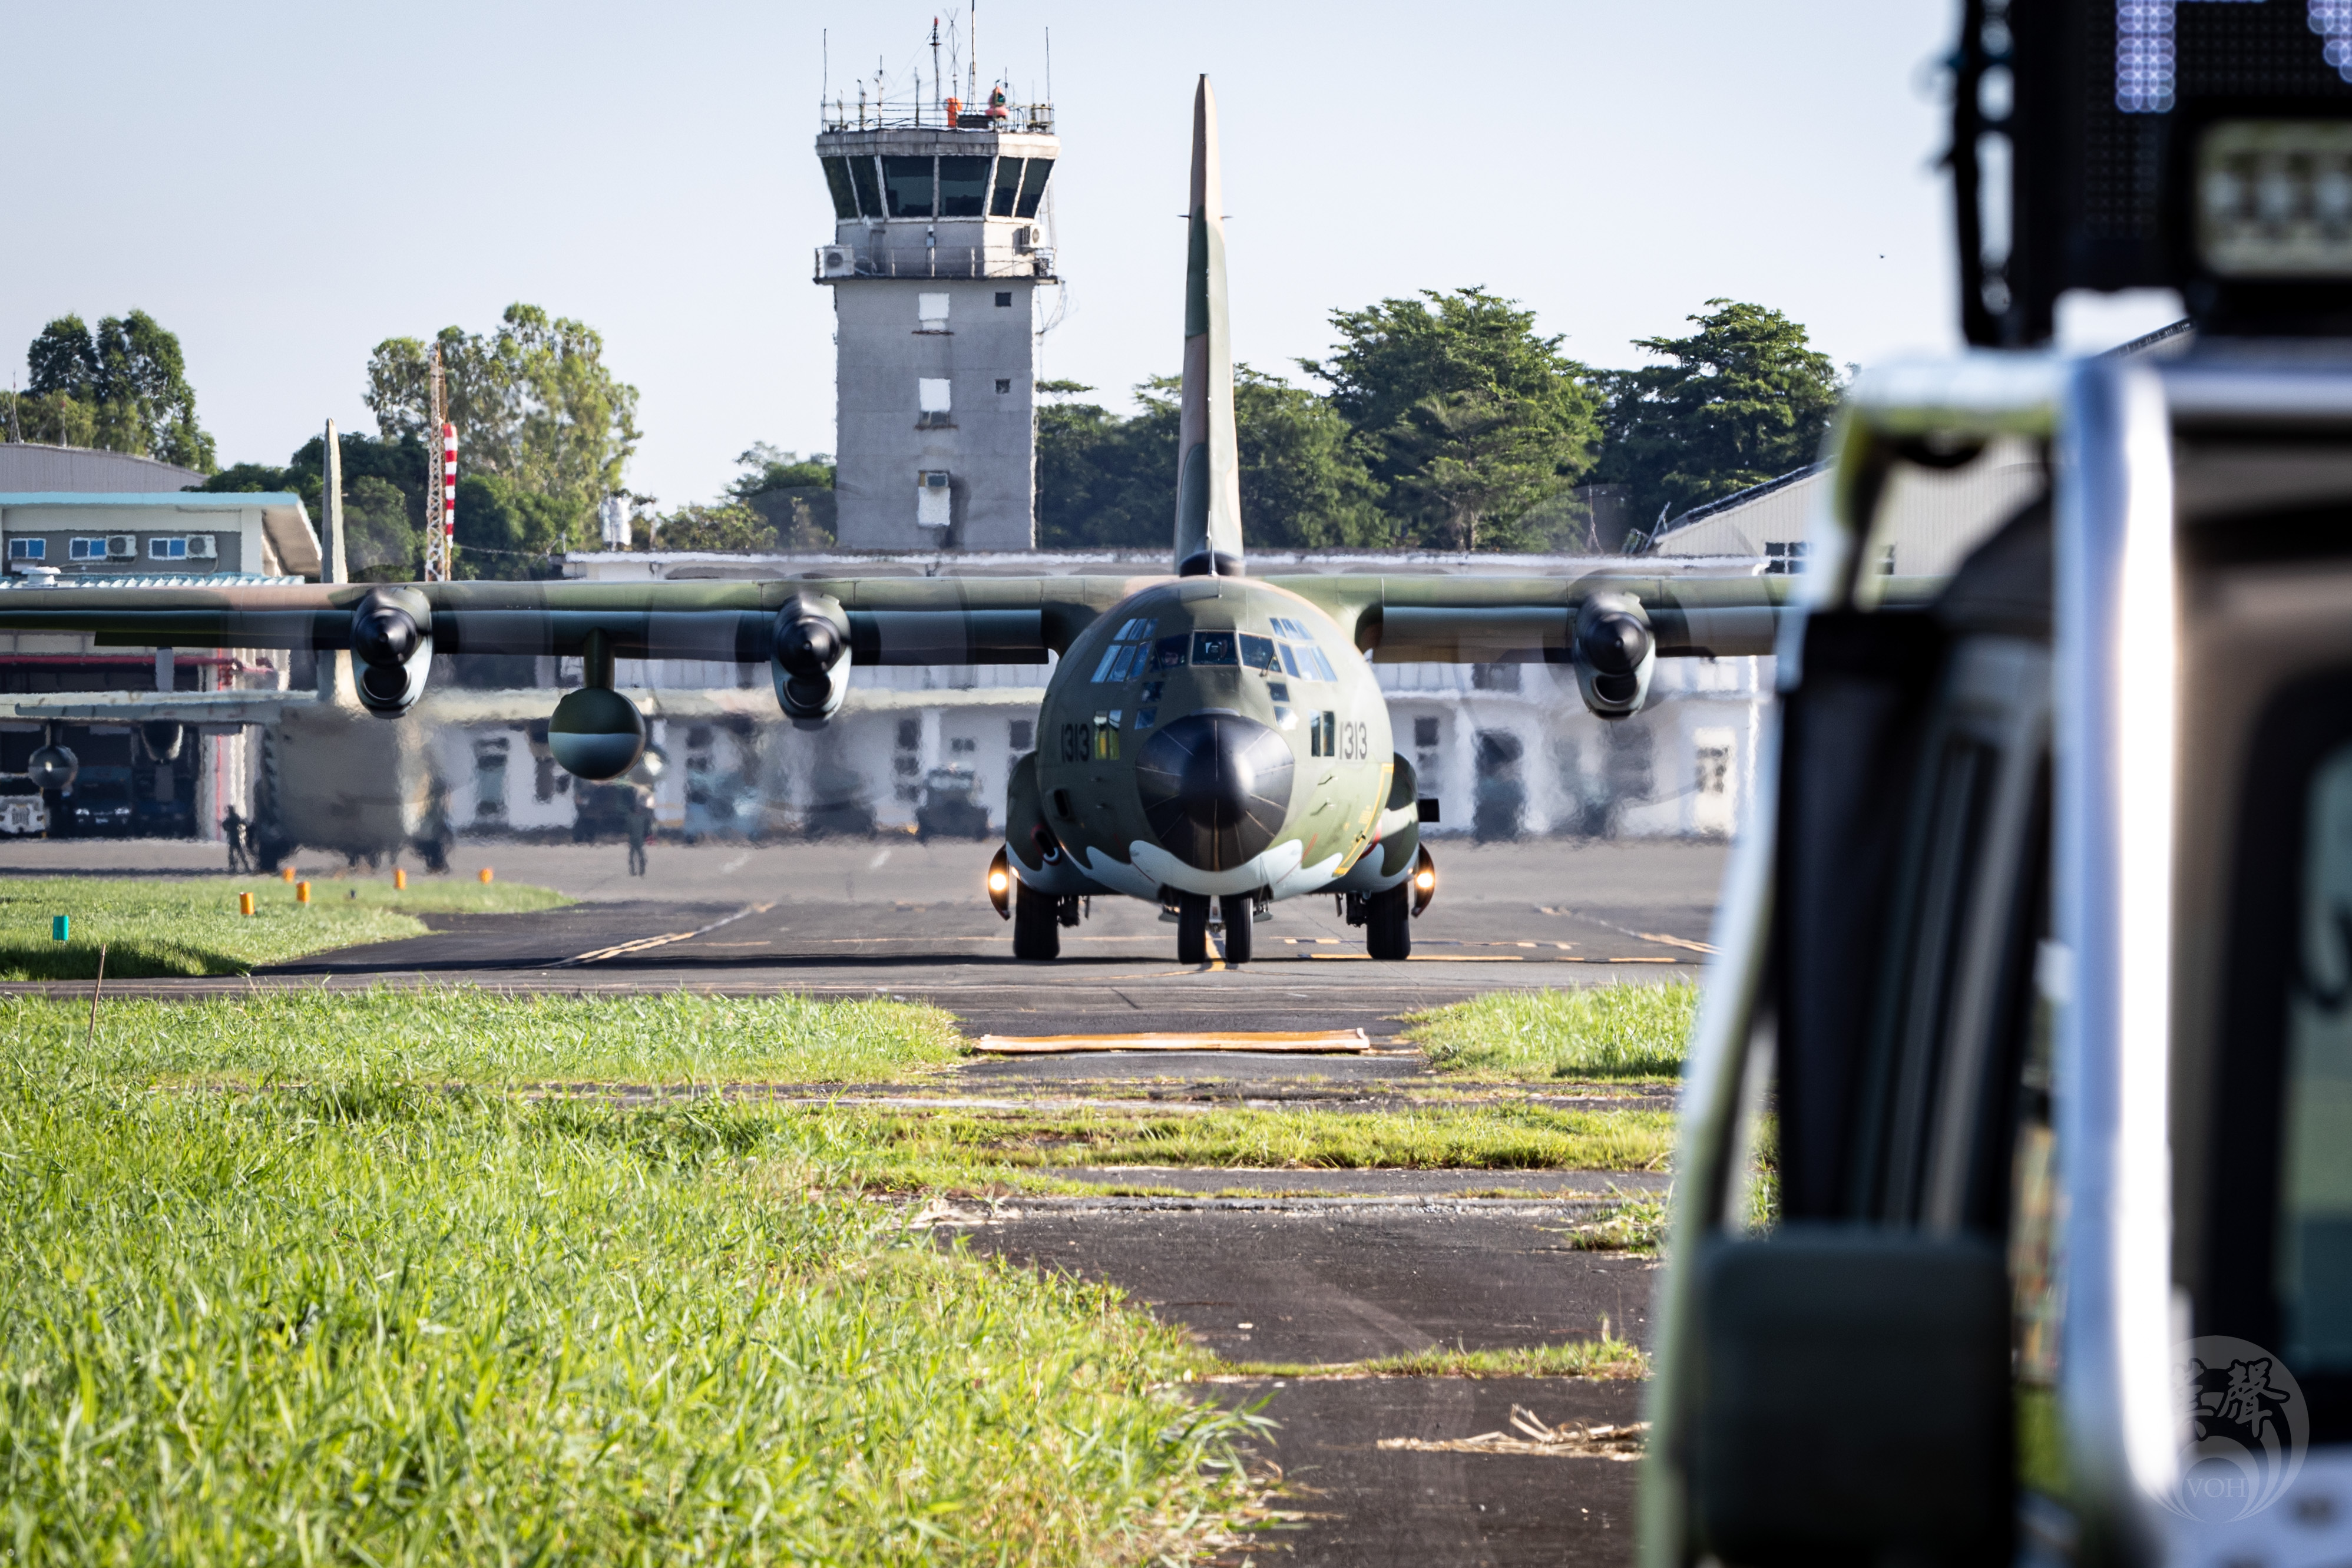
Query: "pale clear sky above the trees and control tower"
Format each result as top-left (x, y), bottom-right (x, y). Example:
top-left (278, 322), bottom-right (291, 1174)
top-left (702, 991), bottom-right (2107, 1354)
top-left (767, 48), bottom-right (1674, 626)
top-left (0, 0), bottom-right (2154, 505)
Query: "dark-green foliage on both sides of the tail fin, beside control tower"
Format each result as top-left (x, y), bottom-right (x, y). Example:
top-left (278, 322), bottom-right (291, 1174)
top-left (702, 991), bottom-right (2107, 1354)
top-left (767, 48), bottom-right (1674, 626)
top-left (1037, 365), bottom-right (1392, 550)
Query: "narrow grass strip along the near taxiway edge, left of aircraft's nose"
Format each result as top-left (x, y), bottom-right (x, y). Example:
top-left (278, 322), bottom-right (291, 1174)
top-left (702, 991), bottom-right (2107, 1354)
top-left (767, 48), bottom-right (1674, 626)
top-left (16, 992), bottom-right (964, 1086)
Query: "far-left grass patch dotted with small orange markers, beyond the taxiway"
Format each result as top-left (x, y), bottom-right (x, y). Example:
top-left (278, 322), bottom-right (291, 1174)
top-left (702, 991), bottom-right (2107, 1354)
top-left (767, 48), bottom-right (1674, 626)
top-left (0, 877), bottom-right (571, 980)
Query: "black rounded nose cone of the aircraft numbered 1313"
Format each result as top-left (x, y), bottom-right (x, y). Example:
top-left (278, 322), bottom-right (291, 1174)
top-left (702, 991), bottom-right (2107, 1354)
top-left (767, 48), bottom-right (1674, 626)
top-left (1136, 712), bottom-right (1291, 872)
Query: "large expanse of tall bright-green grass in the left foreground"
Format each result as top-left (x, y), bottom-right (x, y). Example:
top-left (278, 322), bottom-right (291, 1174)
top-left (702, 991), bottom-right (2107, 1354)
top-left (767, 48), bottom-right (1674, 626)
top-left (0, 1004), bottom-right (1246, 1568)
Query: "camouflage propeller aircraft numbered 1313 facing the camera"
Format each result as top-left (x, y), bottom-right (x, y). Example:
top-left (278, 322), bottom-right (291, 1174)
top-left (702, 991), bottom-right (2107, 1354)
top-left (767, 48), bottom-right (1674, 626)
top-left (0, 78), bottom-right (1790, 964)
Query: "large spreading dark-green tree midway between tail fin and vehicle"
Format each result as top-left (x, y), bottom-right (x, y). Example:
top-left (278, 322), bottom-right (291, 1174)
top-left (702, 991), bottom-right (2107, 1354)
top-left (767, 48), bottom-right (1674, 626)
top-left (1298, 287), bottom-right (1599, 550)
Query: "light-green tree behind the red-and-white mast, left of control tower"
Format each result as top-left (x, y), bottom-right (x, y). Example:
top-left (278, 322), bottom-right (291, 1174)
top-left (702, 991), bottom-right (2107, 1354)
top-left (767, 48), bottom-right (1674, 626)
top-left (367, 303), bottom-right (637, 569)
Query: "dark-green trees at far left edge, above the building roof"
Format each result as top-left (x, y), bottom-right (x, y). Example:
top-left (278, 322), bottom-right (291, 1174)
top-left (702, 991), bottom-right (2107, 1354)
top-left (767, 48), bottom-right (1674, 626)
top-left (0, 310), bottom-right (214, 472)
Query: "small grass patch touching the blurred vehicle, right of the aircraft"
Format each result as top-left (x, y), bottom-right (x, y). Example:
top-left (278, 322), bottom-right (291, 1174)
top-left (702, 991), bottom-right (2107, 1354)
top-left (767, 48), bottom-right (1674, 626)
top-left (1404, 983), bottom-right (1698, 1081)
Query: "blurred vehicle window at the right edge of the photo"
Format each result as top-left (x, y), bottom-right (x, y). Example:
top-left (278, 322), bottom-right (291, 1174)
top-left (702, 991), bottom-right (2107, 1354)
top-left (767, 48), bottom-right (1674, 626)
top-left (2272, 743), bottom-right (2352, 1373)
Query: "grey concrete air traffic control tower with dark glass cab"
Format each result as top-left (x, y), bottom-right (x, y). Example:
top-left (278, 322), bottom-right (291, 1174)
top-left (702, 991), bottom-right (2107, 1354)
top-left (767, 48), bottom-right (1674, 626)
top-left (816, 90), bottom-right (1061, 550)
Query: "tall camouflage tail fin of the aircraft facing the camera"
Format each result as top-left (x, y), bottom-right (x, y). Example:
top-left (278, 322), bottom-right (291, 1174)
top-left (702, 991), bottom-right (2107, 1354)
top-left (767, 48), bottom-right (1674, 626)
top-left (1176, 75), bottom-right (1242, 576)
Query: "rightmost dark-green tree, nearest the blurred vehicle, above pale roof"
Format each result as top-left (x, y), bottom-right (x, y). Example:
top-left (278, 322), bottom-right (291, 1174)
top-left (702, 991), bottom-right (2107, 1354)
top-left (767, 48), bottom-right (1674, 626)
top-left (1595, 299), bottom-right (1842, 540)
